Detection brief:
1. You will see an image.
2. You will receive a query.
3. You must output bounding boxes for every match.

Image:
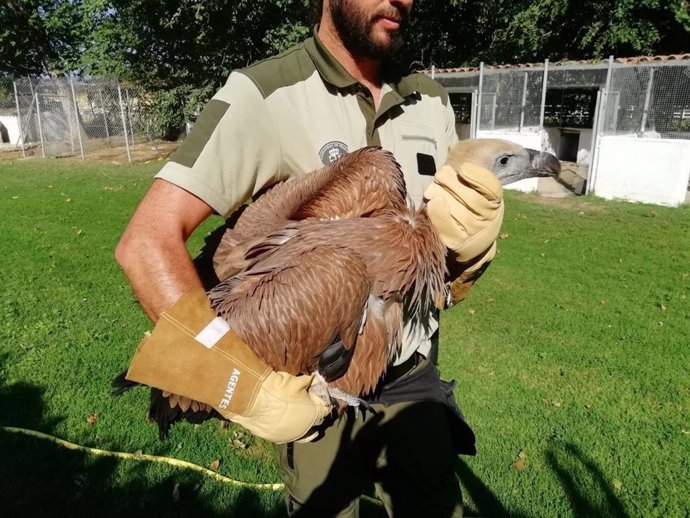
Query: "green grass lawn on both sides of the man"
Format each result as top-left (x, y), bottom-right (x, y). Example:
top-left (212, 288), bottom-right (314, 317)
top-left (0, 160), bottom-right (690, 518)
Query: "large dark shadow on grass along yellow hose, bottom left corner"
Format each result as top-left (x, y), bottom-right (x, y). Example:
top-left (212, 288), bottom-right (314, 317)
top-left (0, 384), bottom-right (285, 518)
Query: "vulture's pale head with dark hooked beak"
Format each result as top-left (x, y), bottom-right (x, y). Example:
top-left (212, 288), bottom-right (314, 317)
top-left (447, 138), bottom-right (561, 185)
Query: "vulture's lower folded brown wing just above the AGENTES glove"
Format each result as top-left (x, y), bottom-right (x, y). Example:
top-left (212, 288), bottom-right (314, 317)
top-left (209, 231), bottom-right (392, 395)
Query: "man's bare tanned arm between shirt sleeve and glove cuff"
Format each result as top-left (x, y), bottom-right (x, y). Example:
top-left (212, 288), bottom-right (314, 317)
top-left (115, 179), bottom-right (213, 323)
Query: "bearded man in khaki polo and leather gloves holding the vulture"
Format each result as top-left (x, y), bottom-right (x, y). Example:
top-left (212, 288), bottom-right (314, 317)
top-left (116, 0), bottom-right (502, 517)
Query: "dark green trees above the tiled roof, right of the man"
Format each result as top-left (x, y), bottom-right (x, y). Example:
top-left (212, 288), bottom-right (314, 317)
top-left (400, 0), bottom-right (690, 67)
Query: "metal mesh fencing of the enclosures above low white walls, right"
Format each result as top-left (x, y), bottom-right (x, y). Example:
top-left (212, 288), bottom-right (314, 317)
top-left (431, 57), bottom-right (690, 139)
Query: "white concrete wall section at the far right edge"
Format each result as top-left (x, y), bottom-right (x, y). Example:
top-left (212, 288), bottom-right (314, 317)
top-left (593, 136), bottom-right (690, 207)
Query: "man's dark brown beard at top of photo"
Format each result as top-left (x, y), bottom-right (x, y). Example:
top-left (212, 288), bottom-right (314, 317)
top-left (330, 0), bottom-right (409, 59)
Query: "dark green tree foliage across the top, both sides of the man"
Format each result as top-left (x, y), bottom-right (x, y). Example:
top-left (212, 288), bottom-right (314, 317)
top-left (0, 0), bottom-right (690, 136)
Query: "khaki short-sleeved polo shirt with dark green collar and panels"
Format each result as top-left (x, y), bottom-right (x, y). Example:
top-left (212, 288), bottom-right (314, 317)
top-left (157, 34), bottom-right (457, 363)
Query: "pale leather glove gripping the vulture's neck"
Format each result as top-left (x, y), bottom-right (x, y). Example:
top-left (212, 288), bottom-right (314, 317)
top-left (424, 162), bottom-right (503, 309)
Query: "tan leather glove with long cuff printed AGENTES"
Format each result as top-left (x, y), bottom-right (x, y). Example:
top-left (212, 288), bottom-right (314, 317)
top-left (127, 288), bottom-right (331, 443)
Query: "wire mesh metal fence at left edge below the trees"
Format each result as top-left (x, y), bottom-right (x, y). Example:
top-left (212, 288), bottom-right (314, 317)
top-left (0, 77), bottom-right (161, 161)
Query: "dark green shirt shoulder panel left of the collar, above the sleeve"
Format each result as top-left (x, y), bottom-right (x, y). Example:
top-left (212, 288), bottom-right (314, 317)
top-left (240, 43), bottom-right (316, 99)
